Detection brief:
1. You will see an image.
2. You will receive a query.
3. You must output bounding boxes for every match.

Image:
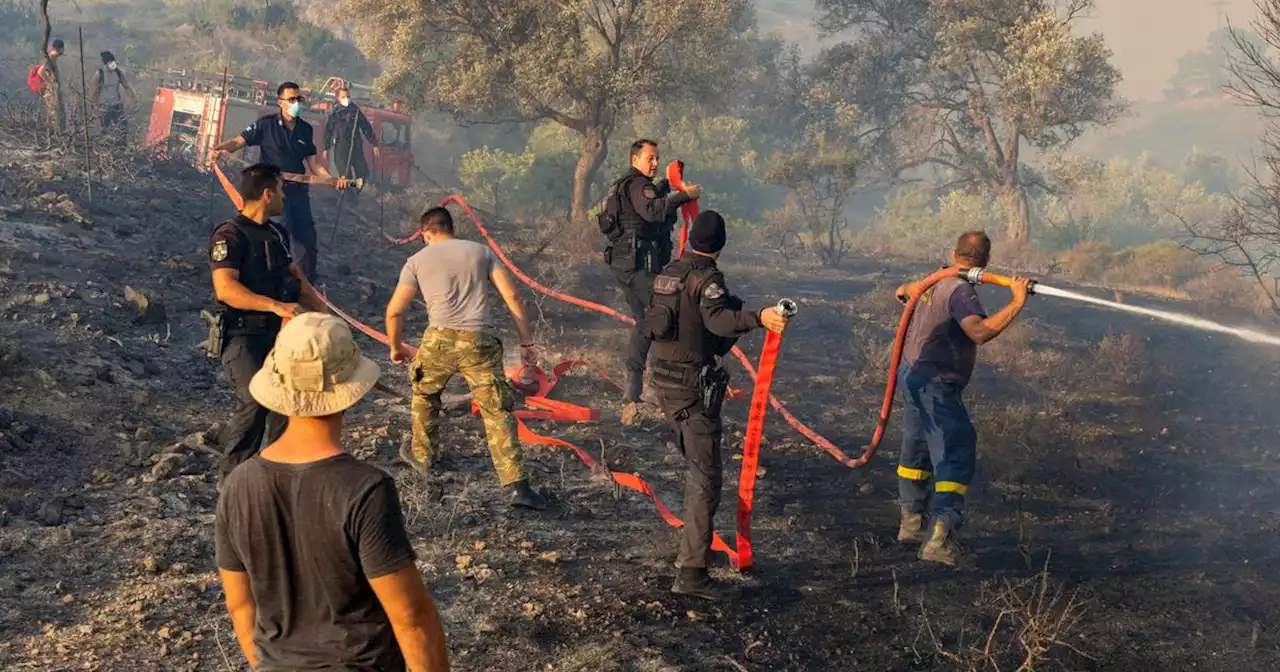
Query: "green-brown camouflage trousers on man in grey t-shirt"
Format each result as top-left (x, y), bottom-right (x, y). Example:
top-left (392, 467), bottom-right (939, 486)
top-left (408, 326), bottom-right (525, 486)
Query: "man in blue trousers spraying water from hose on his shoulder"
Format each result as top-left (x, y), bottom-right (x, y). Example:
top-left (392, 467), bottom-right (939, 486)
top-left (895, 232), bottom-right (1029, 566)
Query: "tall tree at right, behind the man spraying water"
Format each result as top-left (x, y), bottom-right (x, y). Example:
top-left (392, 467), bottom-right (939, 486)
top-left (818, 0), bottom-right (1124, 241)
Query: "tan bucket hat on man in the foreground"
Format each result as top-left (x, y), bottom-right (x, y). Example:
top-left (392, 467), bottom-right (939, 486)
top-left (248, 312), bottom-right (380, 417)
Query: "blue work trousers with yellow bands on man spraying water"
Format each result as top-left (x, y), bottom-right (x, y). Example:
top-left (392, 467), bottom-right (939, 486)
top-left (897, 364), bottom-right (978, 530)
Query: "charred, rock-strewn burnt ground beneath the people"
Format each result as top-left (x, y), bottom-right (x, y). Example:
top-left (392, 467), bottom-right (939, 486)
top-left (0, 144), bottom-right (1280, 672)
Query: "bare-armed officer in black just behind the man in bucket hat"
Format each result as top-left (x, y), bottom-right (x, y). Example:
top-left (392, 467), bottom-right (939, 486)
top-left (205, 164), bottom-right (325, 480)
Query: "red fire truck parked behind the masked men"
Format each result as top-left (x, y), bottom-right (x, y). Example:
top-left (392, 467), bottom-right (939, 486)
top-left (146, 70), bottom-right (413, 191)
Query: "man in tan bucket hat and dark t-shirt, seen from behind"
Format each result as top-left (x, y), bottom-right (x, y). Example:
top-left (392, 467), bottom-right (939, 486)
top-left (216, 312), bottom-right (449, 672)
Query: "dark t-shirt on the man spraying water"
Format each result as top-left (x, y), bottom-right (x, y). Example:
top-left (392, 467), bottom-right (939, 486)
top-left (902, 278), bottom-right (987, 387)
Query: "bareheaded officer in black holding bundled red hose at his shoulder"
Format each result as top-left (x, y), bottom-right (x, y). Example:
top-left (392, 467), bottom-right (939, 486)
top-left (598, 138), bottom-right (701, 425)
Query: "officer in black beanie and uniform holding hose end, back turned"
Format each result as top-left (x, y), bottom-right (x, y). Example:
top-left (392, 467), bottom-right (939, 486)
top-left (644, 210), bottom-right (787, 599)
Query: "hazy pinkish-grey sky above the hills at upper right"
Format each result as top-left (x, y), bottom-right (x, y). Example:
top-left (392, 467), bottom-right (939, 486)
top-left (1080, 0), bottom-right (1256, 100)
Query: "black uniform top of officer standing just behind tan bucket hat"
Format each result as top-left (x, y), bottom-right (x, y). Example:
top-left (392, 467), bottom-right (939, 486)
top-left (220, 218), bottom-right (302, 332)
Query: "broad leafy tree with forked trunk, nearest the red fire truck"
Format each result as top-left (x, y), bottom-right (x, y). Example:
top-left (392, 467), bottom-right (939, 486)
top-left (339, 0), bottom-right (754, 221)
